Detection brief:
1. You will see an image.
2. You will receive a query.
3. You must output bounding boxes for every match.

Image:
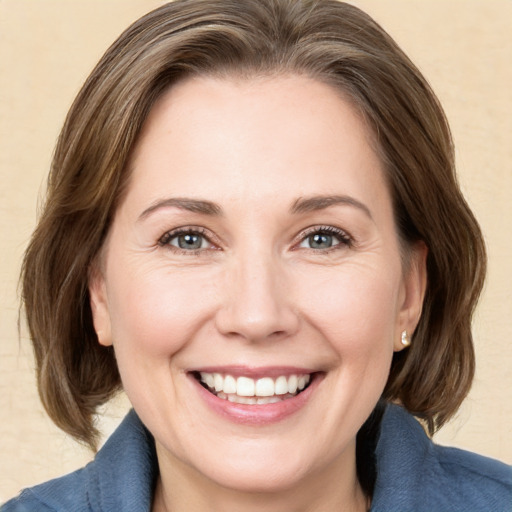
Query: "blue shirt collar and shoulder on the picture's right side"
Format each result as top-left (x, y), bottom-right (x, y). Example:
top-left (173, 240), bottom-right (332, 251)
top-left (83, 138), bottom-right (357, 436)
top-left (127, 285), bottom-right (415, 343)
top-left (372, 406), bottom-right (512, 512)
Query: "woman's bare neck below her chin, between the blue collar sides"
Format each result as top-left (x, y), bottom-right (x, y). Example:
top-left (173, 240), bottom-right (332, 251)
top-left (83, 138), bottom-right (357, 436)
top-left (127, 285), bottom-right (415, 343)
top-left (152, 445), bottom-right (369, 512)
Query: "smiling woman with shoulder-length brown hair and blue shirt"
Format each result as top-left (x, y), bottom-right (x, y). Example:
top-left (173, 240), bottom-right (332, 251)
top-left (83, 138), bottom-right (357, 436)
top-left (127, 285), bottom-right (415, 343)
top-left (3, 0), bottom-right (512, 512)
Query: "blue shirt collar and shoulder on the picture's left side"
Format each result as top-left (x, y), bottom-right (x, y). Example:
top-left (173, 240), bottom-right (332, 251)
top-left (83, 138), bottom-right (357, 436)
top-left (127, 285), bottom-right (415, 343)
top-left (0, 411), bottom-right (157, 512)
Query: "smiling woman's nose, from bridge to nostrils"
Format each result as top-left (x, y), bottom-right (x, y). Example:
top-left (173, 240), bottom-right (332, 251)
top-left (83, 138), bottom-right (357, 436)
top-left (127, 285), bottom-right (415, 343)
top-left (216, 254), bottom-right (299, 342)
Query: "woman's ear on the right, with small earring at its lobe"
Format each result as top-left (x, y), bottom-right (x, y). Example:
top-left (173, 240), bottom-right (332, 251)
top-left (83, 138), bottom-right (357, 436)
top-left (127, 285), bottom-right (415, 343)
top-left (394, 241), bottom-right (428, 352)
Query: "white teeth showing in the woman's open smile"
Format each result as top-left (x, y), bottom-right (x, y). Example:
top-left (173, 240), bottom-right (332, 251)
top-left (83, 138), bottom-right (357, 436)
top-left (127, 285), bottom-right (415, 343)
top-left (200, 372), bottom-right (311, 405)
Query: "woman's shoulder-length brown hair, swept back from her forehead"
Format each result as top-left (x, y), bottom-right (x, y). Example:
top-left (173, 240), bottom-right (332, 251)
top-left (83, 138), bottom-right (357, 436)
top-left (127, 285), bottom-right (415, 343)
top-left (22, 0), bottom-right (486, 447)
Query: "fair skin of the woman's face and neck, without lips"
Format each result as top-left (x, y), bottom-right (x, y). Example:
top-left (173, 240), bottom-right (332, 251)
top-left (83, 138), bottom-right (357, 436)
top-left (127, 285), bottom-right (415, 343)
top-left (90, 76), bottom-right (426, 512)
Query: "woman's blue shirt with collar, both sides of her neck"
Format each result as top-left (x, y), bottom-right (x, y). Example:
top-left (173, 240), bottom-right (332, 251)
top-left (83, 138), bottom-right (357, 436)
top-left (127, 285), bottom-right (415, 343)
top-left (0, 405), bottom-right (512, 512)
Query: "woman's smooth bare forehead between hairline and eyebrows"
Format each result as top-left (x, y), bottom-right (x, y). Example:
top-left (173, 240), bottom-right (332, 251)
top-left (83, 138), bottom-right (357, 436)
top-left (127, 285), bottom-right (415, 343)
top-left (124, 75), bottom-right (387, 213)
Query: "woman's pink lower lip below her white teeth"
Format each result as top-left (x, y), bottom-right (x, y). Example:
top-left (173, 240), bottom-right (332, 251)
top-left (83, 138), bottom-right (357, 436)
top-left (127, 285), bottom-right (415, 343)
top-left (190, 374), bottom-right (322, 426)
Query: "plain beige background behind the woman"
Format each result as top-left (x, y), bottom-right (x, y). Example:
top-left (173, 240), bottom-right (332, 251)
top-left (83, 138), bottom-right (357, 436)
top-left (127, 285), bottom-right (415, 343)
top-left (0, 0), bottom-right (512, 502)
